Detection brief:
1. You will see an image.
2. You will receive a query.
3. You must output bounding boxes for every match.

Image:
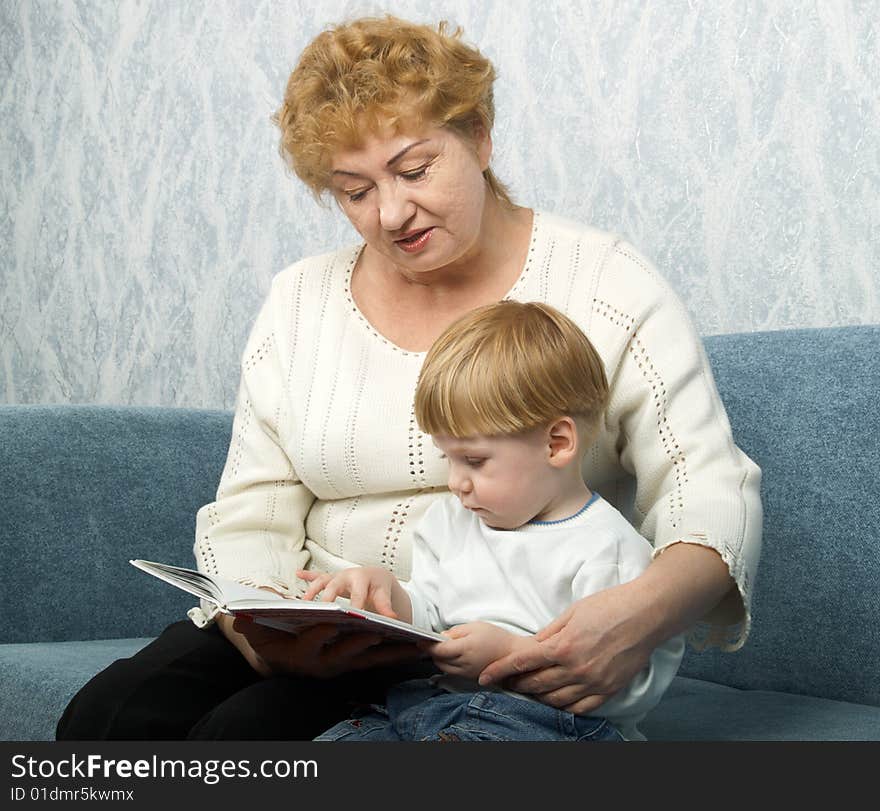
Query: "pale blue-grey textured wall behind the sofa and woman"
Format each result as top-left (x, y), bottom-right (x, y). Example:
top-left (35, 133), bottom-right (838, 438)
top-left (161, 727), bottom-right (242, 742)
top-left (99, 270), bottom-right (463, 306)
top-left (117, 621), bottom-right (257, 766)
top-left (0, 0), bottom-right (880, 407)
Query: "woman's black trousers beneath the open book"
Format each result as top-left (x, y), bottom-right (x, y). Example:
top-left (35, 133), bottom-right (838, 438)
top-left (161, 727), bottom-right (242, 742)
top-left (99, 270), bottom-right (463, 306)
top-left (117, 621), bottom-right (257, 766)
top-left (56, 621), bottom-right (436, 741)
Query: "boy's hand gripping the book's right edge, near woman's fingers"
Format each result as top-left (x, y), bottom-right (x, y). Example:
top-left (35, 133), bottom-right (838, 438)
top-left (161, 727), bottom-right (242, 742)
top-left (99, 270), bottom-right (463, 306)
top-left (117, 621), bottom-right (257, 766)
top-left (428, 622), bottom-right (538, 681)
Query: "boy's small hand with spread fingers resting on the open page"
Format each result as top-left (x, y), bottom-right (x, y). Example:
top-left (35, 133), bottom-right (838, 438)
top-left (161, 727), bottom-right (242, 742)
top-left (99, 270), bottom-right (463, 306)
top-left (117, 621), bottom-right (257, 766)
top-left (296, 566), bottom-right (412, 622)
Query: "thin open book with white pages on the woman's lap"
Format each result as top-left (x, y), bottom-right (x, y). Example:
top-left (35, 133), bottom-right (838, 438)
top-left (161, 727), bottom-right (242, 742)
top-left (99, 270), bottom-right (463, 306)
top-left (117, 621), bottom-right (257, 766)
top-left (129, 560), bottom-right (446, 642)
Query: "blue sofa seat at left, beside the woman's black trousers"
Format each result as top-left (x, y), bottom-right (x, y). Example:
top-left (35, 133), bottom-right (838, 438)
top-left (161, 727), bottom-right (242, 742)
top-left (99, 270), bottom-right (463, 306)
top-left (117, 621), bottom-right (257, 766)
top-left (0, 638), bottom-right (151, 741)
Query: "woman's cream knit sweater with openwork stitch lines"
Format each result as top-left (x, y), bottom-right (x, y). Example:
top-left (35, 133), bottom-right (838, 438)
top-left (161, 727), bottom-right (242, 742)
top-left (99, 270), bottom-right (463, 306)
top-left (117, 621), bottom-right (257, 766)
top-left (190, 212), bottom-right (762, 649)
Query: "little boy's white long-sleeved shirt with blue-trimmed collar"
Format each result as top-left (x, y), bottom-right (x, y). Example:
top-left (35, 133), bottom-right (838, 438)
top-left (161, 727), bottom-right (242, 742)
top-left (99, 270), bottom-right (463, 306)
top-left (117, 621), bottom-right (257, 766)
top-left (402, 494), bottom-right (684, 740)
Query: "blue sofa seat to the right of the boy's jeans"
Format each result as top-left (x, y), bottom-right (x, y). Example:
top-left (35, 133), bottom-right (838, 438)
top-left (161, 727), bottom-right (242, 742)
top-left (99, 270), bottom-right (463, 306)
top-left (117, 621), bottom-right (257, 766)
top-left (641, 676), bottom-right (880, 741)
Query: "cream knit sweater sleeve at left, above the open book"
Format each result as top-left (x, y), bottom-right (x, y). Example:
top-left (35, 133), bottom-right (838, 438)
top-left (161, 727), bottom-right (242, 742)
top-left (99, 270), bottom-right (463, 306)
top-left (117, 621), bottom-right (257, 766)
top-left (189, 280), bottom-right (314, 625)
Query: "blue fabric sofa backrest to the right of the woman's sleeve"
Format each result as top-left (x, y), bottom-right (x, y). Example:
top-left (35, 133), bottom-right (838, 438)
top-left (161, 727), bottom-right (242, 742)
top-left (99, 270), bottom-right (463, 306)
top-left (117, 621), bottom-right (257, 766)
top-left (681, 326), bottom-right (880, 706)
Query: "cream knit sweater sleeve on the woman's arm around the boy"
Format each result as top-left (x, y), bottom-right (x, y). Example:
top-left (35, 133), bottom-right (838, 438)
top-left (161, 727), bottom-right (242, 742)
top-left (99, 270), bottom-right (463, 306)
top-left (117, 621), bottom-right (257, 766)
top-left (594, 238), bottom-right (762, 650)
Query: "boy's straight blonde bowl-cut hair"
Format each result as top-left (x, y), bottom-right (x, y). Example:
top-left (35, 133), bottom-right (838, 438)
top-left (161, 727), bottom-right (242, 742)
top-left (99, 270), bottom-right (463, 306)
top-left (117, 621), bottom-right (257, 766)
top-left (415, 301), bottom-right (608, 448)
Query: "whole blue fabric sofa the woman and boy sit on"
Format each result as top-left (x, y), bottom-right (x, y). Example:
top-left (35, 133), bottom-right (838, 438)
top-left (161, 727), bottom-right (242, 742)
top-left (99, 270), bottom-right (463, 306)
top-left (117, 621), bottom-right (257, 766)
top-left (0, 326), bottom-right (880, 741)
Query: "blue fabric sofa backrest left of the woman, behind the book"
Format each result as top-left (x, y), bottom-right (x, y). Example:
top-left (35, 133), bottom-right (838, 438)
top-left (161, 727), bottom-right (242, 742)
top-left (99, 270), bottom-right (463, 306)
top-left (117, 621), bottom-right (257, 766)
top-left (0, 406), bottom-right (232, 642)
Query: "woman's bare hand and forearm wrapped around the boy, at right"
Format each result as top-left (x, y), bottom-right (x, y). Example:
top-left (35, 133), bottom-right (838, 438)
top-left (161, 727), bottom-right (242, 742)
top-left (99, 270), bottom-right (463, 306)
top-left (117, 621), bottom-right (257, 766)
top-left (479, 543), bottom-right (736, 715)
